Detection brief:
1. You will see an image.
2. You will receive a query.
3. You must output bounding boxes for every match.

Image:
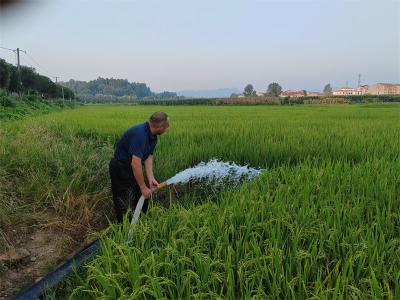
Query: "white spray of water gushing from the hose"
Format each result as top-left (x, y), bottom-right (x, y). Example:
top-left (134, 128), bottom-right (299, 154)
top-left (167, 159), bottom-right (263, 185)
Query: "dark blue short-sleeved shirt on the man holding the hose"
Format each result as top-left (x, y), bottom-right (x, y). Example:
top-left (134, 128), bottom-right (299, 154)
top-left (114, 122), bottom-right (157, 163)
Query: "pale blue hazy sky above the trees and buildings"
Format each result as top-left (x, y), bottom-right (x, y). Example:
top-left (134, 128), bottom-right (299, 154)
top-left (0, 0), bottom-right (400, 92)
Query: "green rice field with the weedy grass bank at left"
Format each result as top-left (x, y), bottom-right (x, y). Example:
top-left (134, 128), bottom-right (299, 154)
top-left (0, 104), bottom-right (400, 299)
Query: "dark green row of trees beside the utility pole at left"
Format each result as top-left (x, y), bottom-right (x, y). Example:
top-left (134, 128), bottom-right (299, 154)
top-left (0, 59), bottom-right (75, 99)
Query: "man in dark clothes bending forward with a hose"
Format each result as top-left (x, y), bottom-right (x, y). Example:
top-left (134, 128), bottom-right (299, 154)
top-left (109, 112), bottom-right (169, 223)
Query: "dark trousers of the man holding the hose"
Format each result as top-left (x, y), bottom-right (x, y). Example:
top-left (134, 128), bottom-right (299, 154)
top-left (109, 158), bottom-right (149, 223)
